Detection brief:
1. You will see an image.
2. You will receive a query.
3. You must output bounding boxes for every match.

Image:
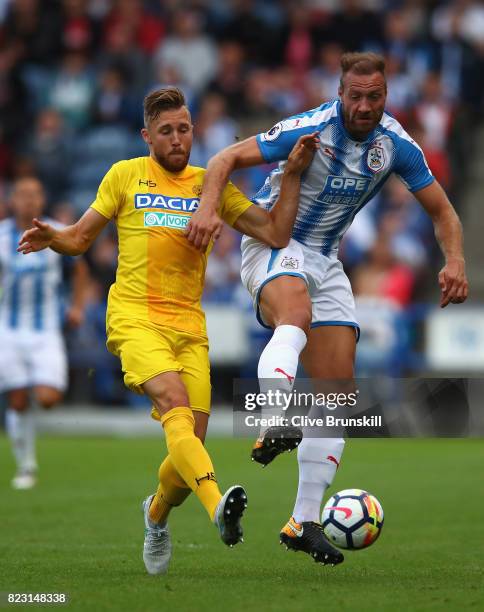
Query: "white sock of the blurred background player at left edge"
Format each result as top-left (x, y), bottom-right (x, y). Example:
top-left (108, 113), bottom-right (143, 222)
top-left (5, 408), bottom-right (37, 472)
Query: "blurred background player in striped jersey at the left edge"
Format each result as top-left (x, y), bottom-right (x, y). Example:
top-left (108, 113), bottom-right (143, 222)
top-left (0, 177), bottom-right (88, 489)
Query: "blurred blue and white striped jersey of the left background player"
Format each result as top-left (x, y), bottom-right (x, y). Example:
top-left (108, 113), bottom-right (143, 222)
top-left (0, 218), bottom-right (71, 331)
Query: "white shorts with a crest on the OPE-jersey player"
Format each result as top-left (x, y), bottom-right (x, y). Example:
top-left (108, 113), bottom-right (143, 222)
top-left (240, 236), bottom-right (360, 339)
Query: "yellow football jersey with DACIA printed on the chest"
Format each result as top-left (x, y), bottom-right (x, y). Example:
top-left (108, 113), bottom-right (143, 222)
top-left (91, 157), bottom-right (251, 336)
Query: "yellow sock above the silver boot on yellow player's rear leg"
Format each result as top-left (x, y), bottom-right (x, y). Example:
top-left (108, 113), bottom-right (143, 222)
top-left (149, 455), bottom-right (192, 523)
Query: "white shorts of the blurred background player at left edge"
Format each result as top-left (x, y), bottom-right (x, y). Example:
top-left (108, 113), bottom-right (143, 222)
top-left (0, 328), bottom-right (67, 391)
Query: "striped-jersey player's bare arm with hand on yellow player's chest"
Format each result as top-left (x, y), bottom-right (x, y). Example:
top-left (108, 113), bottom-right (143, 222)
top-left (185, 136), bottom-right (264, 251)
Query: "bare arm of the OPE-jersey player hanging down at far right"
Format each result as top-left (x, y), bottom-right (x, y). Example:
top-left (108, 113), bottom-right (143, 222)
top-left (414, 181), bottom-right (468, 308)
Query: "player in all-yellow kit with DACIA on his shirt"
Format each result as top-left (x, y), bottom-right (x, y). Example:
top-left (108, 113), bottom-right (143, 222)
top-left (18, 88), bottom-right (318, 574)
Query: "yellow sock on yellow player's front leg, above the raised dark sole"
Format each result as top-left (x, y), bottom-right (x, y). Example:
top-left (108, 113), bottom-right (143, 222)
top-left (161, 407), bottom-right (222, 519)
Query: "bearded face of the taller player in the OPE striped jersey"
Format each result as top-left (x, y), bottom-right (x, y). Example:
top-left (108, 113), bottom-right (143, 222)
top-left (339, 72), bottom-right (387, 139)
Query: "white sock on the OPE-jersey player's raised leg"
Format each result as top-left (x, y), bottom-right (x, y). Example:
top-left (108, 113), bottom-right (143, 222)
top-left (257, 325), bottom-right (307, 435)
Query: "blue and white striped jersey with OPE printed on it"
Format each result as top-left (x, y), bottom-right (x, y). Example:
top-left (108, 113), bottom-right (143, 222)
top-left (253, 100), bottom-right (434, 255)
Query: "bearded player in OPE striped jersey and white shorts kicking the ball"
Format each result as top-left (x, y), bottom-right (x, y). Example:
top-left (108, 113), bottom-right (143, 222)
top-left (187, 53), bottom-right (467, 563)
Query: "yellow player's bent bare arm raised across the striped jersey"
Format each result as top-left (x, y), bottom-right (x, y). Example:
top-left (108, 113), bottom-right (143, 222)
top-left (234, 132), bottom-right (319, 249)
